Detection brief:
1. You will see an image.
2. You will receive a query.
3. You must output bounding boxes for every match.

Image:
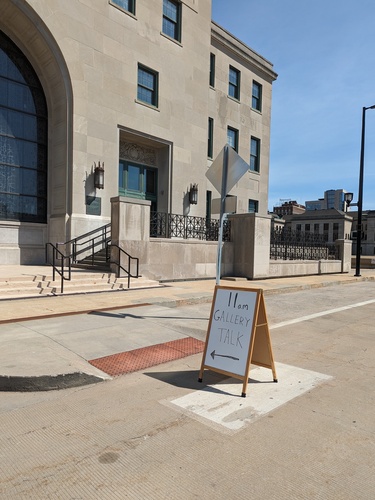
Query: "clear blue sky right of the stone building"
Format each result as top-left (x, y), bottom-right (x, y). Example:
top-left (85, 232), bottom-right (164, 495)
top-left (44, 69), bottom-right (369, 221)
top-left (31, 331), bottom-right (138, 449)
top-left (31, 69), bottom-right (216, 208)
top-left (212, 0), bottom-right (375, 210)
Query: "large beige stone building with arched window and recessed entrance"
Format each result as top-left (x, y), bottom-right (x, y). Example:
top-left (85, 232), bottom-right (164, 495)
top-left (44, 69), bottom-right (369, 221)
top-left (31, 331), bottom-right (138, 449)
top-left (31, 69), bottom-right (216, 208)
top-left (0, 0), bottom-right (277, 264)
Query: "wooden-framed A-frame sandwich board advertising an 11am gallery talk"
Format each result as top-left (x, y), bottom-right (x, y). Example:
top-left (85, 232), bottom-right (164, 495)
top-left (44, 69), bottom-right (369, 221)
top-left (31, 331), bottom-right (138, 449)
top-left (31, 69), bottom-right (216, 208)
top-left (198, 285), bottom-right (277, 397)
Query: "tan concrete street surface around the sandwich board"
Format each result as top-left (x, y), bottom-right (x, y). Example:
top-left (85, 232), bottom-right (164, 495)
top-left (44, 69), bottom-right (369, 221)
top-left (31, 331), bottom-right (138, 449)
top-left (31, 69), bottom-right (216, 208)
top-left (0, 282), bottom-right (375, 500)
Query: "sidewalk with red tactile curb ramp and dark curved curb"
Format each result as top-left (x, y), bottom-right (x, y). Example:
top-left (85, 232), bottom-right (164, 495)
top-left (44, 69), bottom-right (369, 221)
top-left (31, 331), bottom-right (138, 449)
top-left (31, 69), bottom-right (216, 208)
top-left (0, 266), bottom-right (375, 391)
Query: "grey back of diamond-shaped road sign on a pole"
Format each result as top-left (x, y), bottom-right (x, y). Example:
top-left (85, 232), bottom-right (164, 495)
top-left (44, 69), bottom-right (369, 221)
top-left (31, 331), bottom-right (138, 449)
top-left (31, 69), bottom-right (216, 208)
top-left (206, 146), bottom-right (250, 196)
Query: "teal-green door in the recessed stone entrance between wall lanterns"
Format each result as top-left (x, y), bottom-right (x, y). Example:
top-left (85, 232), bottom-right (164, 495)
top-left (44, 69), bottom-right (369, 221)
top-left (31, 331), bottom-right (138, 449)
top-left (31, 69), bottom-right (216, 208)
top-left (119, 160), bottom-right (157, 212)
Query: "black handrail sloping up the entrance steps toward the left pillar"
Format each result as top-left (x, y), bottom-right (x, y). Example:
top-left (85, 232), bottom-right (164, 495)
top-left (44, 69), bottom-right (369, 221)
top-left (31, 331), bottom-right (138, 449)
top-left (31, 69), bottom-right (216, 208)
top-left (56, 223), bottom-right (111, 265)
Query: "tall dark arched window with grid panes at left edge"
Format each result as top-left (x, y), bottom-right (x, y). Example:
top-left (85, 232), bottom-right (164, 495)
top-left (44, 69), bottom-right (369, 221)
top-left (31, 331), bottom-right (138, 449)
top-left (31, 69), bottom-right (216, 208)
top-left (0, 31), bottom-right (47, 223)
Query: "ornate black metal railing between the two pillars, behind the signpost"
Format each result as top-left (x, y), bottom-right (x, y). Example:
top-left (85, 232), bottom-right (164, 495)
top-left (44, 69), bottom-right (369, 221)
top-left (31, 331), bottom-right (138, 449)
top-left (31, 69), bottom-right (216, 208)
top-left (150, 212), bottom-right (230, 241)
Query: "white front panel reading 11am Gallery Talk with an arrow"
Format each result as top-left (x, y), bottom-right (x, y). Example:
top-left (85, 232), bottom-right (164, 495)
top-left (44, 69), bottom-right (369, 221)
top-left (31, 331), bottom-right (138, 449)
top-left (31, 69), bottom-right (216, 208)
top-left (204, 288), bottom-right (257, 377)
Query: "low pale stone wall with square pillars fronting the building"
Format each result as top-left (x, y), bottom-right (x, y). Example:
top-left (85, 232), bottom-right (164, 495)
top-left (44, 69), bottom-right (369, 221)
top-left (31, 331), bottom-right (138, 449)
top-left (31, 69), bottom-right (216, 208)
top-left (111, 200), bottom-right (351, 286)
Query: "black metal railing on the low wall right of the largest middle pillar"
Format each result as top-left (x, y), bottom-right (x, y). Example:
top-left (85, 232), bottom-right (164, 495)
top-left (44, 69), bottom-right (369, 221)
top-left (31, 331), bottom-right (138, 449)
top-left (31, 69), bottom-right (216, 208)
top-left (270, 228), bottom-right (339, 260)
